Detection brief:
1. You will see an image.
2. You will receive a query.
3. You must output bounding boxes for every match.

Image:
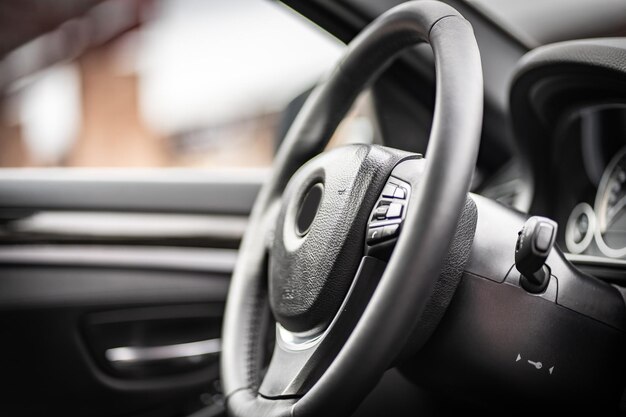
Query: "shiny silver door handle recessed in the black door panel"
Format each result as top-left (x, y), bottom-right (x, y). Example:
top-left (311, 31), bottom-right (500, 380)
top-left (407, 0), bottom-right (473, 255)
top-left (104, 339), bottom-right (222, 365)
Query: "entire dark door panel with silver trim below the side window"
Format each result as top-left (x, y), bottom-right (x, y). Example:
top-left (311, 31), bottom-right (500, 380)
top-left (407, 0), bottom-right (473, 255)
top-left (0, 178), bottom-right (260, 417)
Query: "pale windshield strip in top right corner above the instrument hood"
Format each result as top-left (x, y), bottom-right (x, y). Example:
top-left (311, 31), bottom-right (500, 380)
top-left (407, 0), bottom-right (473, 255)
top-left (465, 0), bottom-right (626, 48)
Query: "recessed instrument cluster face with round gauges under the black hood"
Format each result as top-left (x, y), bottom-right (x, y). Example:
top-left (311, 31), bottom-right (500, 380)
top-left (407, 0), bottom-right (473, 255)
top-left (550, 106), bottom-right (626, 260)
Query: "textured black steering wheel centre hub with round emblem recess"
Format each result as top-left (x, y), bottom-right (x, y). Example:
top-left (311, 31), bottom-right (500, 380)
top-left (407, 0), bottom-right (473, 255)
top-left (269, 145), bottom-right (408, 333)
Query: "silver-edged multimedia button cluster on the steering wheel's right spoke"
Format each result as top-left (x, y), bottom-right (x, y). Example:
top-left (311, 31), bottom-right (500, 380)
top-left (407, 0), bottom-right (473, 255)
top-left (366, 177), bottom-right (411, 246)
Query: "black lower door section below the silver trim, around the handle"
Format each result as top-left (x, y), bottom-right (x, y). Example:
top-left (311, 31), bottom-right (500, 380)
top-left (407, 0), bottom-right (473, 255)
top-left (0, 252), bottom-right (229, 416)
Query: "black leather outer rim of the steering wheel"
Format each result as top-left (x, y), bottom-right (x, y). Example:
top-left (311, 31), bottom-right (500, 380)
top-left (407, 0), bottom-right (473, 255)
top-left (221, 1), bottom-right (483, 417)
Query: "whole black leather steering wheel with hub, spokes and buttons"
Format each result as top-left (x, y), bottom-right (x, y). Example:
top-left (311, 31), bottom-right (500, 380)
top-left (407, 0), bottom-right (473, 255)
top-left (221, 1), bottom-right (483, 417)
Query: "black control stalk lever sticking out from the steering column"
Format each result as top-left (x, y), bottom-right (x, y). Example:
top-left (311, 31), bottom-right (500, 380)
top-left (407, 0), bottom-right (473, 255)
top-left (515, 216), bottom-right (557, 294)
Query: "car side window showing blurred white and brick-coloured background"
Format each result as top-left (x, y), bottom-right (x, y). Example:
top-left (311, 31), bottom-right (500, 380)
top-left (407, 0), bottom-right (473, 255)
top-left (0, 0), bottom-right (374, 168)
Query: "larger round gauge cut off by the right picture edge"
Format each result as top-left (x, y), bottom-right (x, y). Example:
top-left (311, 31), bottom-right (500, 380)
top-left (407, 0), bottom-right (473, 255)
top-left (594, 148), bottom-right (626, 258)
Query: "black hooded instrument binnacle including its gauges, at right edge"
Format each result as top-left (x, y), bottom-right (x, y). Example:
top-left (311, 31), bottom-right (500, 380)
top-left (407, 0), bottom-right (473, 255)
top-left (509, 38), bottom-right (626, 291)
